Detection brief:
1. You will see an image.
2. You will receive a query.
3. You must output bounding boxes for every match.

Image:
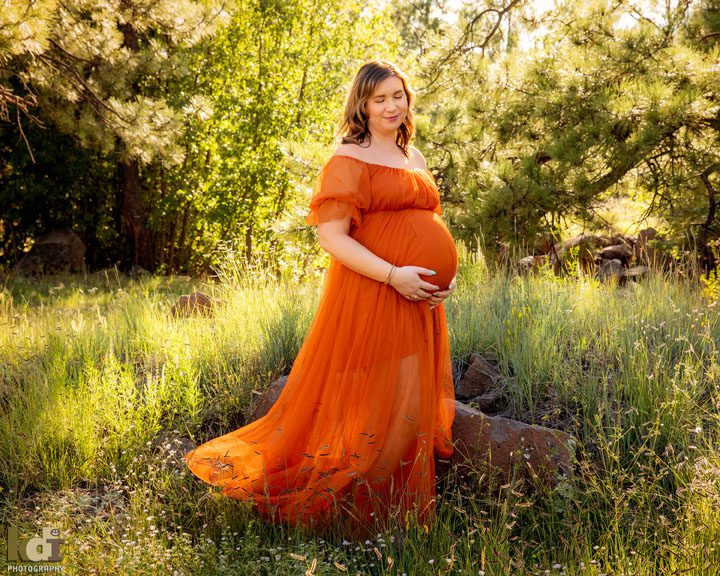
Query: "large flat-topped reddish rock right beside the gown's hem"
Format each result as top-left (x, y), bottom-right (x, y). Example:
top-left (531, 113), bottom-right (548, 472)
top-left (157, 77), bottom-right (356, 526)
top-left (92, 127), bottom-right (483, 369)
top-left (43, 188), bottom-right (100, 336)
top-left (450, 402), bottom-right (574, 486)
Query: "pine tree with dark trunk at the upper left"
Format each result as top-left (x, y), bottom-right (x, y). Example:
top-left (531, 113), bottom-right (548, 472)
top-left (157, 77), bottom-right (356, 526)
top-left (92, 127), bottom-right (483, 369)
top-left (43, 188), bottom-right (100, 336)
top-left (8, 0), bottom-right (227, 269)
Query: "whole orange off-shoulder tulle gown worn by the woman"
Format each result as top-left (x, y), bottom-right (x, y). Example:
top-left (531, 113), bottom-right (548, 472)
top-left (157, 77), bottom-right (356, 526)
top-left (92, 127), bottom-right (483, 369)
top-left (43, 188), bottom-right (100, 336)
top-left (185, 155), bottom-right (457, 534)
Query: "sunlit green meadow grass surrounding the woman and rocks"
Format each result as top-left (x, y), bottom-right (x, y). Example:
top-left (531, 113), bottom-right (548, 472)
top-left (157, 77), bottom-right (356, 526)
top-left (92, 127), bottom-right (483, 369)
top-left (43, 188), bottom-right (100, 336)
top-left (0, 250), bottom-right (720, 576)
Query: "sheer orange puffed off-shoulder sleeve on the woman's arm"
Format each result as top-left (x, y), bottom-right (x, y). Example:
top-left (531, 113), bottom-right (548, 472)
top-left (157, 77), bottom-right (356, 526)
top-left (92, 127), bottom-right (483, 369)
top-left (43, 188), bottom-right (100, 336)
top-left (305, 156), bottom-right (370, 226)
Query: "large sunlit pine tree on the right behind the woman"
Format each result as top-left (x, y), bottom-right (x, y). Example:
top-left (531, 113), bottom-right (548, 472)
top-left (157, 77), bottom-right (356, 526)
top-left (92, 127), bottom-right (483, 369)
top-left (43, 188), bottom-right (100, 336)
top-left (452, 1), bottom-right (720, 264)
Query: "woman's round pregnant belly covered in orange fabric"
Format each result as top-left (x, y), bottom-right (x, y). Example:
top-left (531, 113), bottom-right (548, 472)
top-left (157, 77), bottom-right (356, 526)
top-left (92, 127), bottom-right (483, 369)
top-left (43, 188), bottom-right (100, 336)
top-left (354, 209), bottom-right (457, 290)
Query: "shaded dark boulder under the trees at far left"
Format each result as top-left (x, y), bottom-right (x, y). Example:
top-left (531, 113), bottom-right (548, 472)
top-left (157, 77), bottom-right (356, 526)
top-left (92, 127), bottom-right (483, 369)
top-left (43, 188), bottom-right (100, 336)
top-left (15, 228), bottom-right (85, 276)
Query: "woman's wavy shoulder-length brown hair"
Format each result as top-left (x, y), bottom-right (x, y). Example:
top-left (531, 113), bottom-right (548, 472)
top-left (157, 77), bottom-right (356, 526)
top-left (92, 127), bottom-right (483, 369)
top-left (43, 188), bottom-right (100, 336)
top-left (338, 60), bottom-right (415, 158)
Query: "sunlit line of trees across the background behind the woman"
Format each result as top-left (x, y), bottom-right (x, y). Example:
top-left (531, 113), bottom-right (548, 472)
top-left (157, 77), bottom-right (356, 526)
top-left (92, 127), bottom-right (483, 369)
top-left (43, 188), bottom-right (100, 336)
top-left (0, 0), bottom-right (720, 273)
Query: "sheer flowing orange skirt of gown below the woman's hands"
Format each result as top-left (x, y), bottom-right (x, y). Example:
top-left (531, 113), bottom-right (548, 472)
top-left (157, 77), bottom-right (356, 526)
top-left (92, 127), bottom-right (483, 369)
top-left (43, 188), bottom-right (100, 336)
top-left (185, 259), bottom-right (454, 534)
